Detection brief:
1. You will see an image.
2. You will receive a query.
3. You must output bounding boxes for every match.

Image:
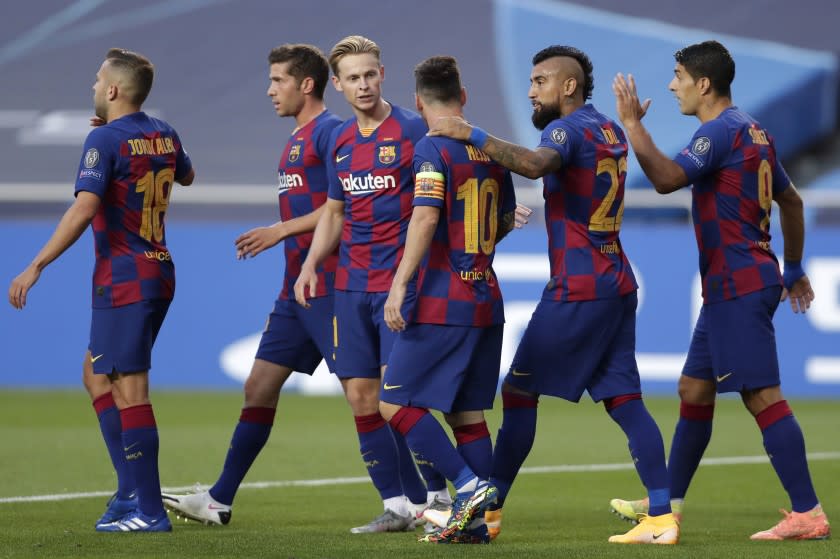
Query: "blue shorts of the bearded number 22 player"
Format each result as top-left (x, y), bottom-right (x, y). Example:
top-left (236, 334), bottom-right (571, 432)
top-left (505, 291), bottom-right (641, 402)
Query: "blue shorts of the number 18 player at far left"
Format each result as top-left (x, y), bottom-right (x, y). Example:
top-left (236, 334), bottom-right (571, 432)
top-left (88, 299), bottom-right (172, 375)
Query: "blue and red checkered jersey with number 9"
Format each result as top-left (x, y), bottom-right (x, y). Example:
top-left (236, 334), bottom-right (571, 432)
top-left (674, 107), bottom-right (790, 303)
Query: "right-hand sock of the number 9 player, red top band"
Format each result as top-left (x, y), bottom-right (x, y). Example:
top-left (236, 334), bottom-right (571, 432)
top-left (755, 400), bottom-right (819, 512)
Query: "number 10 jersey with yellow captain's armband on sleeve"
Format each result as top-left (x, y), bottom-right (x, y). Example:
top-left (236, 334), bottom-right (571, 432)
top-left (414, 137), bottom-right (516, 326)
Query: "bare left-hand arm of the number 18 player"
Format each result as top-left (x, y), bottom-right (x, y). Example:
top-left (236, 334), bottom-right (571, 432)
top-left (9, 190), bottom-right (100, 309)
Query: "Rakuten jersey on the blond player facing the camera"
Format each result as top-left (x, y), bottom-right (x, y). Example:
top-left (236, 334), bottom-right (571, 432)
top-left (327, 105), bottom-right (428, 292)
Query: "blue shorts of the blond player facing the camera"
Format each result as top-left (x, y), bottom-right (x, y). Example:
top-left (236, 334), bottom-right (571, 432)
top-left (335, 289), bottom-right (414, 379)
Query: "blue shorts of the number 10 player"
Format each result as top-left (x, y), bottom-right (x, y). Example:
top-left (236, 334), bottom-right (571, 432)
top-left (379, 324), bottom-right (504, 413)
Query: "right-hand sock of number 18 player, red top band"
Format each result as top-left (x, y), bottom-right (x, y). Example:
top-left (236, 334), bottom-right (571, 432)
top-left (120, 404), bottom-right (164, 516)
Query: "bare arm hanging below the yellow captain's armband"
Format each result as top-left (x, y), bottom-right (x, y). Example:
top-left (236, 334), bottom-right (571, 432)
top-left (385, 206), bottom-right (440, 332)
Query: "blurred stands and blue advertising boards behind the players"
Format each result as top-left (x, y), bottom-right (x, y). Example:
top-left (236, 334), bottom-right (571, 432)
top-left (0, 0), bottom-right (840, 397)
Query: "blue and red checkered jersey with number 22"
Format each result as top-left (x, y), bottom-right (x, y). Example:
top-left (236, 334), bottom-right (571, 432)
top-left (539, 104), bottom-right (637, 301)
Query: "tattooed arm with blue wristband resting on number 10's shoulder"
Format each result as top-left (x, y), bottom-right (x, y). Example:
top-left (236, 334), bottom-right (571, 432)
top-left (429, 116), bottom-right (563, 179)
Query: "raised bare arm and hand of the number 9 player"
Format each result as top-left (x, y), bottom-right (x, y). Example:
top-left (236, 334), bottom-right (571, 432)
top-left (613, 74), bottom-right (689, 194)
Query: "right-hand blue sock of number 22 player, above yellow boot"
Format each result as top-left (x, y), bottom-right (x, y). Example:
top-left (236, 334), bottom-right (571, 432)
top-left (604, 394), bottom-right (671, 516)
